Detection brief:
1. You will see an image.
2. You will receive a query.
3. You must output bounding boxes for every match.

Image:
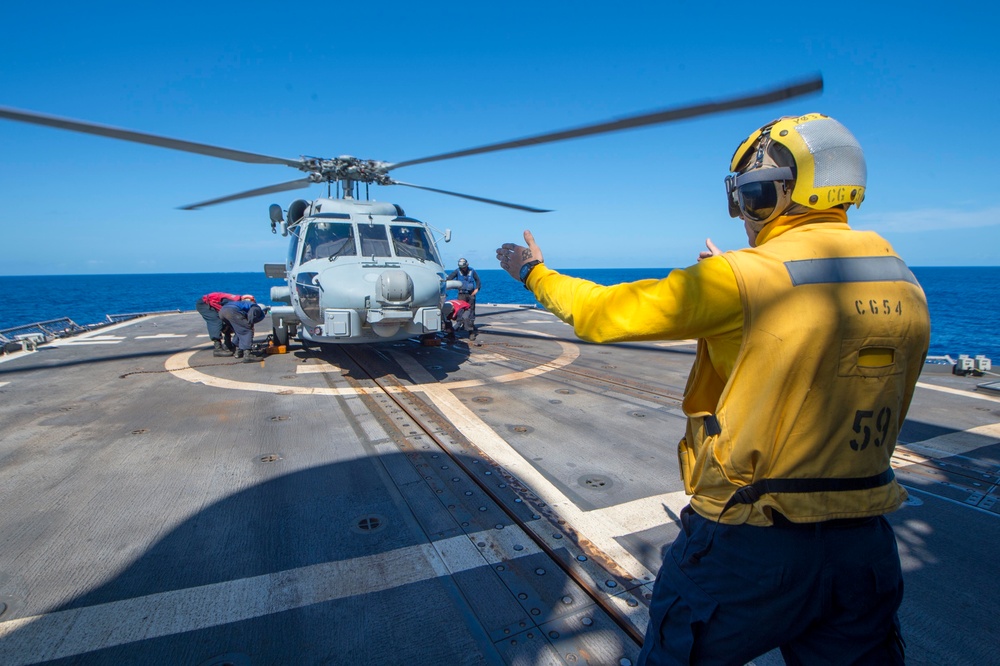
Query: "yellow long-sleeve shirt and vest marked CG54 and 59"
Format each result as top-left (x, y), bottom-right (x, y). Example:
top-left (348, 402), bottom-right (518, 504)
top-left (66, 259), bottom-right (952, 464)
top-left (528, 210), bottom-right (928, 525)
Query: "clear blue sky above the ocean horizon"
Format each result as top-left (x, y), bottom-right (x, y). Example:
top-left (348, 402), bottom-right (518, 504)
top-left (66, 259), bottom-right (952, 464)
top-left (0, 0), bottom-right (1000, 275)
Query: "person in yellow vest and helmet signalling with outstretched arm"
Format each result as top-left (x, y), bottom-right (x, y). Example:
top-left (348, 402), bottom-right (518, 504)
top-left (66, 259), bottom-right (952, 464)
top-left (497, 113), bottom-right (930, 666)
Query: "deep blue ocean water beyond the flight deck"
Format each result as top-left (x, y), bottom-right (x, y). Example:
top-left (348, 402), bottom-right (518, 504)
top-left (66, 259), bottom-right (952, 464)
top-left (0, 267), bottom-right (1000, 363)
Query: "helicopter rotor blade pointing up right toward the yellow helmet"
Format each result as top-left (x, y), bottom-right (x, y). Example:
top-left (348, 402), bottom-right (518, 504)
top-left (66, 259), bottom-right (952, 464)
top-left (387, 76), bottom-right (823, 170)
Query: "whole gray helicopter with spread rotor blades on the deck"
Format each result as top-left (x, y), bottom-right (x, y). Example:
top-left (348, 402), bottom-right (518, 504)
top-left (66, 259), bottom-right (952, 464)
top-left (0, 76), bottom-right (823, 347)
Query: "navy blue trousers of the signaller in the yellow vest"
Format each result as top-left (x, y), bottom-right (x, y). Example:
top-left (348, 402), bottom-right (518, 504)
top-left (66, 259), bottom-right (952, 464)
top-left (639, 507), bottom-right (903, 666)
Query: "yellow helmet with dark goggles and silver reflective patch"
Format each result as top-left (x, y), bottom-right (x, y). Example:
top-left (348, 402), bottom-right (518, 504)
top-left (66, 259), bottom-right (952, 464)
top-left (726, 113), bottom-right (868, 231)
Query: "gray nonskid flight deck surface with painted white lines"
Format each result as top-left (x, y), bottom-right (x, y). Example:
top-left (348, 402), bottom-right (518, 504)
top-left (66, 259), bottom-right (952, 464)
top-left (0, 306), bottom-right (1000, 664)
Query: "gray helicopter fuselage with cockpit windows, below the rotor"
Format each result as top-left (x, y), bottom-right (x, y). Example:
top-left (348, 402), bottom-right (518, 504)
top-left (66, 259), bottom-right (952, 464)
top-left (265, 199), bottom-right (447, 344)
